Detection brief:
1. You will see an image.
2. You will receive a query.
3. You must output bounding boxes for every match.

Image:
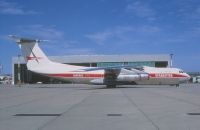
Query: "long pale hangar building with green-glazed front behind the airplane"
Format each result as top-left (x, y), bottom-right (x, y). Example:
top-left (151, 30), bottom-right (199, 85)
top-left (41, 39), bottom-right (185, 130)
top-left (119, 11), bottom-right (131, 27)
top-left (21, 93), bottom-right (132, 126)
top-left (12, 54), bottom-right (171, 84)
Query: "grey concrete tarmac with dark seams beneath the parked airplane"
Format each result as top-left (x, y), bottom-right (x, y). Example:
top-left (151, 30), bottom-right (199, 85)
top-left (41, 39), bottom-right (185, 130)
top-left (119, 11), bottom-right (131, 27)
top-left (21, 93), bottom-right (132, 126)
top-left (0, 84), bottom-right (200, 130)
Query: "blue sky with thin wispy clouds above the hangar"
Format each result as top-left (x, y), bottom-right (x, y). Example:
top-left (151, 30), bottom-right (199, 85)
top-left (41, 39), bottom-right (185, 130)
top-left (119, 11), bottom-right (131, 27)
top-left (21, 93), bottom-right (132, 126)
top-left (0, 0), bottom-right (200, 73)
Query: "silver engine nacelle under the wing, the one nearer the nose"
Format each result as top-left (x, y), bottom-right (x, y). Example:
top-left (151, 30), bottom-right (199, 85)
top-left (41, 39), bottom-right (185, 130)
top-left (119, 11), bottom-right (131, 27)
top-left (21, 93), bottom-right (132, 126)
top-left (117, 74), bottom-right (149, 82)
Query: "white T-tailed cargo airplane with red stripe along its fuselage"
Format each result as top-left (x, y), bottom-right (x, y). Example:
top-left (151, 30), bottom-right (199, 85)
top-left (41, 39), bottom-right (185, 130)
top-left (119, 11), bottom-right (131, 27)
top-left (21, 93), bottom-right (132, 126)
top-left (9, 35), bottom-right (190, 88)
